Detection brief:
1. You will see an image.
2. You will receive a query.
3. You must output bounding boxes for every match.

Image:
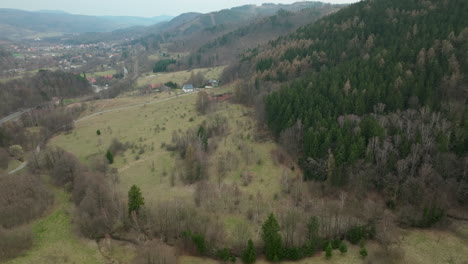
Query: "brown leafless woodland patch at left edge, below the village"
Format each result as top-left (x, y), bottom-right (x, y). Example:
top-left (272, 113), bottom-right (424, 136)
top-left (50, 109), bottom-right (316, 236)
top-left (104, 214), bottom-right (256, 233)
top-left (0, 70), bottom-right (92, 116)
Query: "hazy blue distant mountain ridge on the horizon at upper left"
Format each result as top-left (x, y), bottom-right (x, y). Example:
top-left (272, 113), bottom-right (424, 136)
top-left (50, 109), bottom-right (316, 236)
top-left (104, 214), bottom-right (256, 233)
top-left (0, 8), bottom-right (171, 39)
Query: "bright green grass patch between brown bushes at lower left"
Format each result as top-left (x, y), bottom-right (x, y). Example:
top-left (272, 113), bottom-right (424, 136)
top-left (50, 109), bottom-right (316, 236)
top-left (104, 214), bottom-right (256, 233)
top-left (7, 184), bottom-right (104, 264)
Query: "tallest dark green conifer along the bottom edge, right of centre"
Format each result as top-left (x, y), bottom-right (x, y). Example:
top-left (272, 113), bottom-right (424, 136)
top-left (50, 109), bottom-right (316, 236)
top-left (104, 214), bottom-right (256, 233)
top-left (262, 214), bottom-right (282, 261)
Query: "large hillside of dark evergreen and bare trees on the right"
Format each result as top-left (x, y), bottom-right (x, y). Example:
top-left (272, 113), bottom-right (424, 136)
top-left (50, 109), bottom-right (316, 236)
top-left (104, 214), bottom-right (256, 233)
top-left (229, 0), bottom-right (468, 223)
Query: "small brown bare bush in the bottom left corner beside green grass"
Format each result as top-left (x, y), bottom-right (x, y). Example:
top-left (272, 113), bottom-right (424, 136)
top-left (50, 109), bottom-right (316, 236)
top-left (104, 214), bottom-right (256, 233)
top-left (0, 226), bottom-right (33, 261)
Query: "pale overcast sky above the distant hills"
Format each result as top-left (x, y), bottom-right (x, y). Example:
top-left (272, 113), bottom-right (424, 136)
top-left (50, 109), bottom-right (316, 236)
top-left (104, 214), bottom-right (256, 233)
top-left (0, 0), bottom-right (357, 17)
